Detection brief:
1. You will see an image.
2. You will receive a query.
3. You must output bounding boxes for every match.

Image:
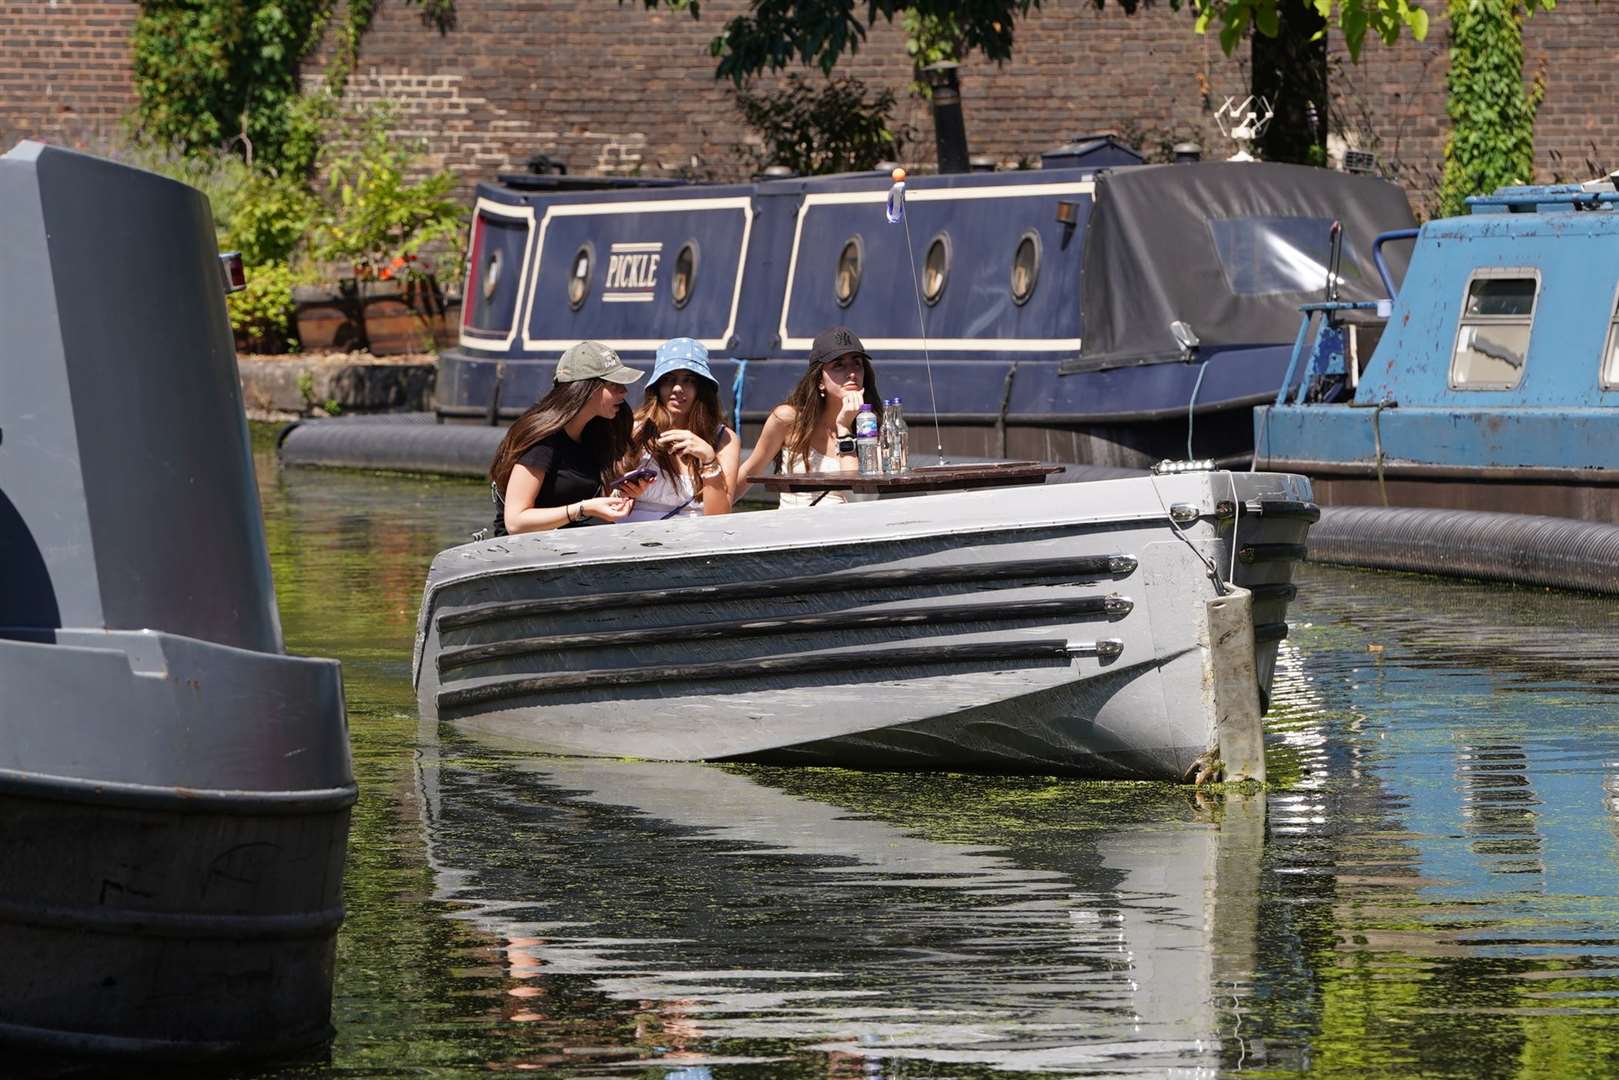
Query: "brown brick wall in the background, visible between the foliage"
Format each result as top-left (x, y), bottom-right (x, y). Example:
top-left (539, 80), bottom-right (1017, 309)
top-left (0, 0), bottom-right (1619, 220)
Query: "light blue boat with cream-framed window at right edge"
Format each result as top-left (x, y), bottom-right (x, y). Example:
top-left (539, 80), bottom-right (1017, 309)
top-left (1255, 173), bottom-right (1619, 525)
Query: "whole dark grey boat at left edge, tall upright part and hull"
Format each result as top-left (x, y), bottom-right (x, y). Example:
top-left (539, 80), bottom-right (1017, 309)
top-left (0, 142), bottom-right (355, 1074)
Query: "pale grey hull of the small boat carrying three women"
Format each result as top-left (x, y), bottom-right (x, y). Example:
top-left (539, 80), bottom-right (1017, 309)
top-left (416, 473), bottom-right (1311, 779)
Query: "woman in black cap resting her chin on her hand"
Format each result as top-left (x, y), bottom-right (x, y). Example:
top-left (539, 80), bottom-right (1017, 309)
top-left (742, 325), bottom-right (882, 510)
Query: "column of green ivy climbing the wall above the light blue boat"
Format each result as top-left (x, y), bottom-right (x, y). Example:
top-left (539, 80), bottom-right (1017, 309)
top-left (1439, 0), bottom-right (1553, 215)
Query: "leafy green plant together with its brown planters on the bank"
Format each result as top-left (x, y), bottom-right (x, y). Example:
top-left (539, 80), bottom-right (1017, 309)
top-left (314, 110), bottom-right (465, 356)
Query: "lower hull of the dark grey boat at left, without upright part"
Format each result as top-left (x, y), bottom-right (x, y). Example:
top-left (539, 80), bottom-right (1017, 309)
top-left (0, 630), bottom-right (355, 1061)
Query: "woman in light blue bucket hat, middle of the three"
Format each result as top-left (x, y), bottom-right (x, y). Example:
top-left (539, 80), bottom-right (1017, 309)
top-left (627, 337), bottom-right (742, 521)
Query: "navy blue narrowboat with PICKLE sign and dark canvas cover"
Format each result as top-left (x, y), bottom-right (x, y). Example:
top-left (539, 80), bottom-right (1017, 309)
top-left (436, 149), bottom-right (1413, 466)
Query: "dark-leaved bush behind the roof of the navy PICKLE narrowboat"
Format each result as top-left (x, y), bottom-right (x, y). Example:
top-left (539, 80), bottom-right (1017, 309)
top-left (737, 71), bottom-right (903, 175)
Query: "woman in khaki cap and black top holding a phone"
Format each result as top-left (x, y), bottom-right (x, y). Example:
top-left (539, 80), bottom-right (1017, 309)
top-left (489, 342), bottom-right (644, 536)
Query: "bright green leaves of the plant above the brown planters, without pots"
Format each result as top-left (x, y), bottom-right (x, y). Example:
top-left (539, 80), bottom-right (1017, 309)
top-left (314, 110), bottom-right (465, 280)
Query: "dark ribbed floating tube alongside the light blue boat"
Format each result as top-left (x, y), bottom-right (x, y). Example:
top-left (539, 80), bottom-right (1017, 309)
top-left (1310, 507), bottom-right (1619, 594)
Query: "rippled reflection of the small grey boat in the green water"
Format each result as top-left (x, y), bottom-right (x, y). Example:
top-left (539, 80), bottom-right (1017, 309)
top-left (419, 743), bottom-right (1264, 1077)
